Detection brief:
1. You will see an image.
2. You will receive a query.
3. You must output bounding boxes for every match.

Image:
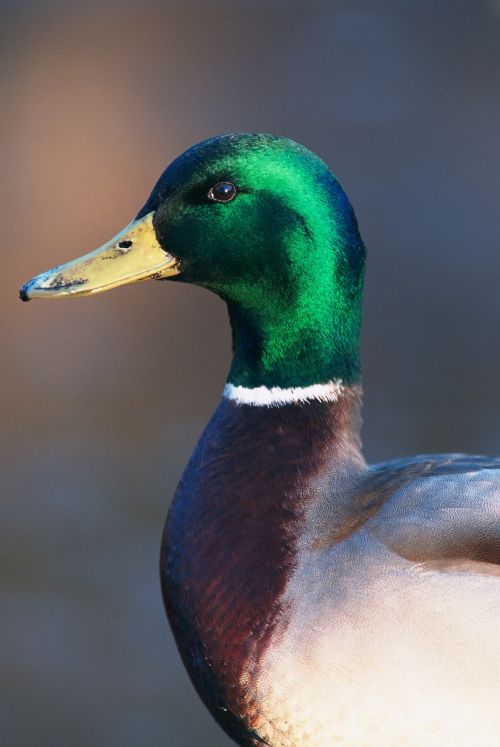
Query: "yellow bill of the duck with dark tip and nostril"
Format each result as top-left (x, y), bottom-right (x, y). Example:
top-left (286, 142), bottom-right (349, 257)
top-left (19, 213), bottom-right (179, 301)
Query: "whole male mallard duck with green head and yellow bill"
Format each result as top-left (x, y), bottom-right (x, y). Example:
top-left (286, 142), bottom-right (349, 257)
top-left (21, 134), bottom-right (500, 747)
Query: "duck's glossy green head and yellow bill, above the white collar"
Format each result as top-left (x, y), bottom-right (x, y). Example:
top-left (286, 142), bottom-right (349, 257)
top-left (20, 134), bottom-right (365, 387)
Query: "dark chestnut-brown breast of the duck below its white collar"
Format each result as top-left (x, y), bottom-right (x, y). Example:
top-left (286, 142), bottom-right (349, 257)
top-left (161, 396), bottom-right (359, 745)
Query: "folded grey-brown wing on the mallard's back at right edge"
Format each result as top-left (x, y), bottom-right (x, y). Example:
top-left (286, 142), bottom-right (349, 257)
top-left (365, 455), bottom-right (500, 575)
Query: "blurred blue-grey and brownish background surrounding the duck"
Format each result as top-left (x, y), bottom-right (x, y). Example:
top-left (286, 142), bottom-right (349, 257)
top-left (0, 0), bottom-right (500, 747)
